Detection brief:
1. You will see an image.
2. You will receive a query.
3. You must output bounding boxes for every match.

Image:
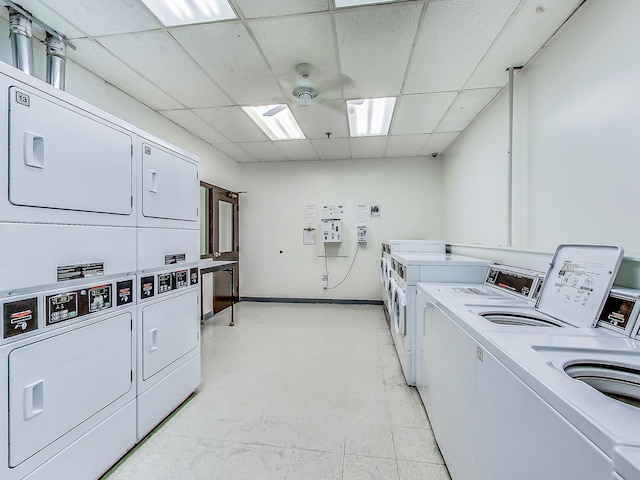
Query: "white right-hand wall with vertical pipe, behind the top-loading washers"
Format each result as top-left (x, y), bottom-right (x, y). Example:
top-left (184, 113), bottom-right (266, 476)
top-left (443, 0), bottom-right (640, 287)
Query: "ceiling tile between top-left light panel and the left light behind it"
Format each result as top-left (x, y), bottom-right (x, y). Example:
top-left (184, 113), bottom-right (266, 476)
top-left (171, 22), bottom-right (283, 105)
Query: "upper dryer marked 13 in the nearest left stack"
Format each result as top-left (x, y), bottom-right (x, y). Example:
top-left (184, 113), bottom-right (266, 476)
top-left (0, 63), bottom-right (137, 295)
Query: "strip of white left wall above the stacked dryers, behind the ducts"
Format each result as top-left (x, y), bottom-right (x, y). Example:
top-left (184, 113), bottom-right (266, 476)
top-left (0, 18), bottom-right (239, 190)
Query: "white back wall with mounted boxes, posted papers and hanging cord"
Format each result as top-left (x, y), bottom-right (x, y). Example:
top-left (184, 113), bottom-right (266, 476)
top-left (240, 158), bottom-right (442, 300)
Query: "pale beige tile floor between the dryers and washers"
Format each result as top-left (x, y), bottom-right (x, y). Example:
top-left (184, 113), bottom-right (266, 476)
top-left (105, 302), bottom-right (450, 480)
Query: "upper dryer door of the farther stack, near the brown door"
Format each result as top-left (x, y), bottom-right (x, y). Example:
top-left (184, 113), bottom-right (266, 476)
top-left (142, 143), bottom-right (200, 222)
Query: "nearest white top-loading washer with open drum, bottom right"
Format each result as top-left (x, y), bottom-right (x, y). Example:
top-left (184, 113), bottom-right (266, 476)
top-left (475, 329), bottom-right (640, 480)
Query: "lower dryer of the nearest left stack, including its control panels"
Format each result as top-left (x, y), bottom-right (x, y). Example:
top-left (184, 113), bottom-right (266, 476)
top-left (0, 276), bottom-right (137, 480)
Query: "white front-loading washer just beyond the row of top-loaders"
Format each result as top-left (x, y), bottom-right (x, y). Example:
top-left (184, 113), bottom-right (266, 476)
top-left (390, 253), bottom-right (491, 385)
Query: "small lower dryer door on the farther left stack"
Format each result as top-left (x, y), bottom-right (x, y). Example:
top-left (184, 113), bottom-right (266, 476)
top-left (142, 290), bottom-right (200, 380)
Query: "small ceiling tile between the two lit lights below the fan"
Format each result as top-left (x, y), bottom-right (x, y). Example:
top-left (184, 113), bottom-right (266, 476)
top-left (291, 100), bottom-right (349, 139)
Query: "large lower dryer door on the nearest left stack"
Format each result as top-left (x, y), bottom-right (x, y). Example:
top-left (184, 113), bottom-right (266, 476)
top-left (8, 312), bottom-right (133, 467)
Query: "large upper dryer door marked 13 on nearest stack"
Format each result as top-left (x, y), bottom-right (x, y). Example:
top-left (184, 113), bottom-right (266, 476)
top-left (9, 87), bottom-right (133, 215)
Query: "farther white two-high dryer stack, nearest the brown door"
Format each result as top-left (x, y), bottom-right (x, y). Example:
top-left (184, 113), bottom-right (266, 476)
top-left (136, 132), bottom-right (200, 438)
